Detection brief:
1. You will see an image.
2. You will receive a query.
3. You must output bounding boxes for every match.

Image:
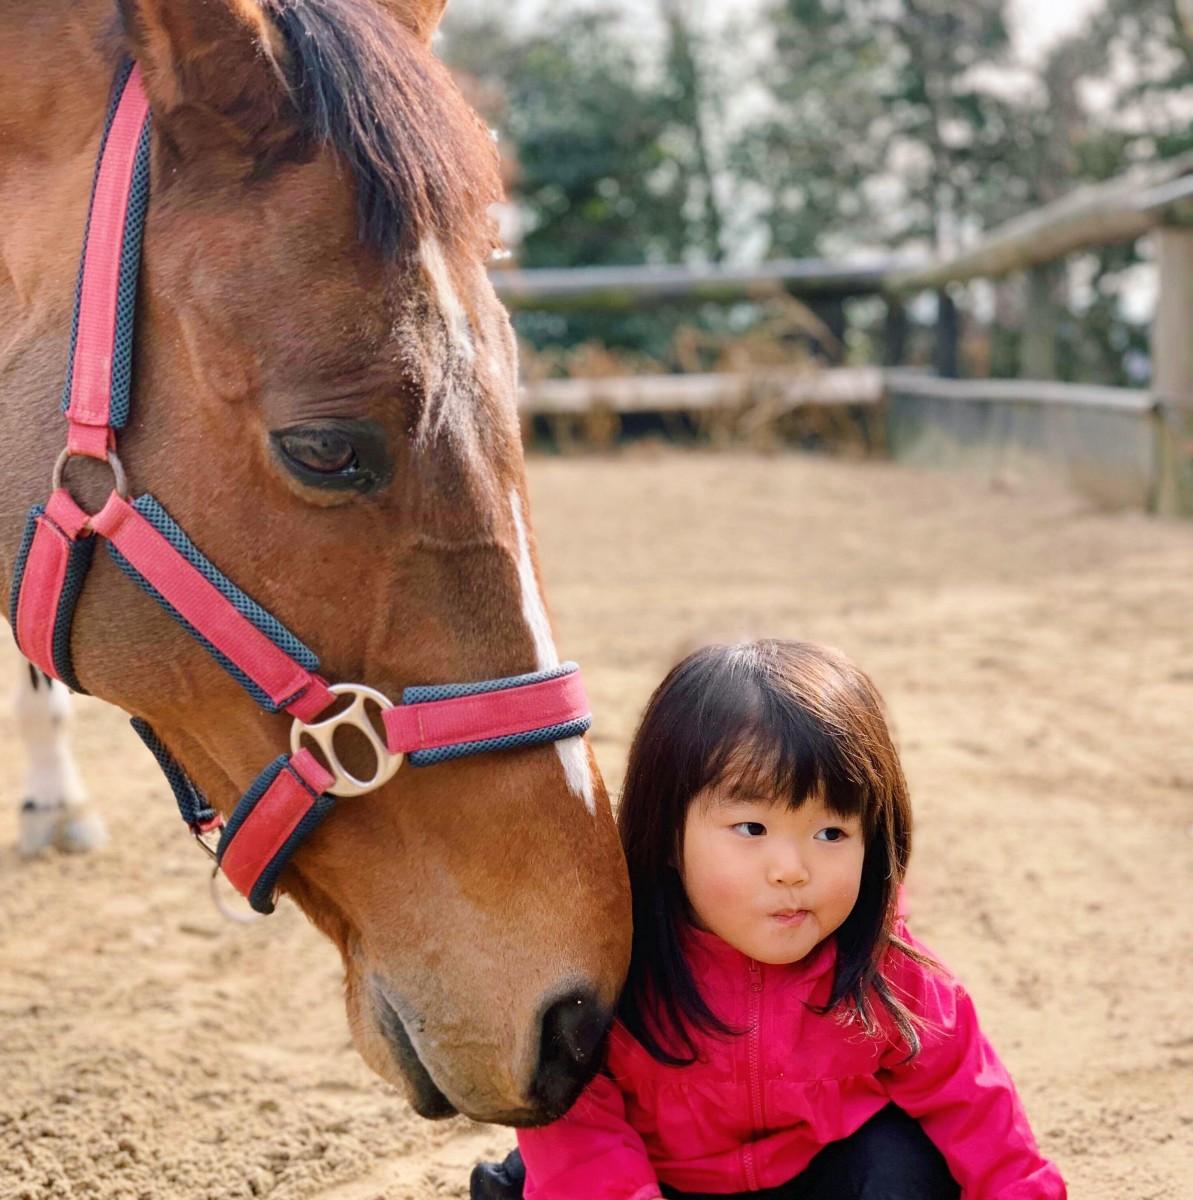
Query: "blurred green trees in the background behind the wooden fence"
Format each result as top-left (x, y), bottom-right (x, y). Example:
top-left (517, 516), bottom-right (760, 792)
top-left (446, 0), bottom-right (1193, 382)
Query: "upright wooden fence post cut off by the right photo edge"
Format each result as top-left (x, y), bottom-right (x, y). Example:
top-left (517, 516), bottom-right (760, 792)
top-left (1152, 226), bottom-right (1193, 516)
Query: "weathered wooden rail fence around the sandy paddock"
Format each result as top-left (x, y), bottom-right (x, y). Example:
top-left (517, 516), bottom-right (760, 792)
top-left (493, 156), bottom-right (1193, 516)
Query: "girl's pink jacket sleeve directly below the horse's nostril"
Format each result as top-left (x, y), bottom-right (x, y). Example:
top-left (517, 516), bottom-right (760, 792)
top-left (517, 1074), bottom-right (660, 1200)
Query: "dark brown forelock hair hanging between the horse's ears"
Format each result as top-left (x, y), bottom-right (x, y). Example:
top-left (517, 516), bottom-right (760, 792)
top-left (266, 0), bottom-right (502, 257)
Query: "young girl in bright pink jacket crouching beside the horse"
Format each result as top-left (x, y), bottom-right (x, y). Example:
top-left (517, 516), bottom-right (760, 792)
top-left (472, 642), bottom-right (1066, 1200)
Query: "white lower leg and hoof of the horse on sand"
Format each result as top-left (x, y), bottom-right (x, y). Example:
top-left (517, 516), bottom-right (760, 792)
top-left (14, 664), bottom-right (108, 856)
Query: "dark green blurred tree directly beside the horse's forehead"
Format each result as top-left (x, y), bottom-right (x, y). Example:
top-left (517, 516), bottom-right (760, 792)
top-left (444, 0), bottom-right (721, 361)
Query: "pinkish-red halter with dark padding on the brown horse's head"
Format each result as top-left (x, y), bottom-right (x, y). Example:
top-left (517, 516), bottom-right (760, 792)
top-left (10, 61), bottom-right (592, 913)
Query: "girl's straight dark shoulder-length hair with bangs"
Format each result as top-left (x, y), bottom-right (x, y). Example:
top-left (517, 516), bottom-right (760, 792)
top-left (617, 641), bottom-right (928, 1066)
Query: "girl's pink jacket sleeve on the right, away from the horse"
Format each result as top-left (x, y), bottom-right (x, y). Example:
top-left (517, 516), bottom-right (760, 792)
top-left (882, 930), bottom-right (1067, 1200)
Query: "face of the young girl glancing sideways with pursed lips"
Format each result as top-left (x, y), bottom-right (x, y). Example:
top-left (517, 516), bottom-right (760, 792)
top-left (681, 784), bottom-right (865, 964)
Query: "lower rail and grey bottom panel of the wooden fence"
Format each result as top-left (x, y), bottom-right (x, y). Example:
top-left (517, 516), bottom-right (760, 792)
top-left (522, 367), bottom-right (1163, 509)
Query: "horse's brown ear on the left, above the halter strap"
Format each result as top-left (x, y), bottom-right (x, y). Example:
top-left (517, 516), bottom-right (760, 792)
top-left (120, 0), bottom-right (286, 150)
